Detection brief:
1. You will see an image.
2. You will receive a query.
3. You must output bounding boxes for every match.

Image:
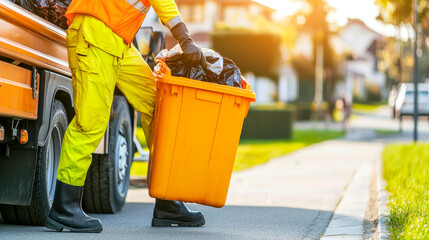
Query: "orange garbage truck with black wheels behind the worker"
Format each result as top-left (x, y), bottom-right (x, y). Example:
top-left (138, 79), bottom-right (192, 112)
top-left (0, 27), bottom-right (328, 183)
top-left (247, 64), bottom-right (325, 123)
top-left (0, 0), bottom-right (164, 225)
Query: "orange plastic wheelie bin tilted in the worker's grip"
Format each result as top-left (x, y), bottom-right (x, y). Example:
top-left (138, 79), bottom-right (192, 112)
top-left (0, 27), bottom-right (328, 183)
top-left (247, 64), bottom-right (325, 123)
top-left (148, 60), bottom-right (255, 207)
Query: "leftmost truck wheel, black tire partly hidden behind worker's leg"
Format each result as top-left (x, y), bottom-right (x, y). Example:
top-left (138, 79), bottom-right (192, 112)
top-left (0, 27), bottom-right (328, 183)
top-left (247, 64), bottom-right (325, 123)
top-left (0, 100), bottom-right (68, 226)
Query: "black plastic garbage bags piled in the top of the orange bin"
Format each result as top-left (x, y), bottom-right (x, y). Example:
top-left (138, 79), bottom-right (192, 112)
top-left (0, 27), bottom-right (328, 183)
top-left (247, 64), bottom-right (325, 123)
top-left (156, 45), bottom-right (243, 88)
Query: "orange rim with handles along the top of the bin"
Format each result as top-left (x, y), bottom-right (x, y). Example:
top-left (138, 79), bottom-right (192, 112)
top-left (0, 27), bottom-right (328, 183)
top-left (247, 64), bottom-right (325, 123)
top-left (155, 61), bottom-right (256, 102)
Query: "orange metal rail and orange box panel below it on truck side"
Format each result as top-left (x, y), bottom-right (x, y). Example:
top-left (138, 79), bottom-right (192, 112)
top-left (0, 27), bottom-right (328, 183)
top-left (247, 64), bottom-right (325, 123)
top-left (0, 1), bottom-right (70, 120)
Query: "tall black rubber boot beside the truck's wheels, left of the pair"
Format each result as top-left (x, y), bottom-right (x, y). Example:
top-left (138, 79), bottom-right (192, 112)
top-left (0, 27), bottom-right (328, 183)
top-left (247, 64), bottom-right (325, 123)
top-left (46, 180), bottom-right (103, 233)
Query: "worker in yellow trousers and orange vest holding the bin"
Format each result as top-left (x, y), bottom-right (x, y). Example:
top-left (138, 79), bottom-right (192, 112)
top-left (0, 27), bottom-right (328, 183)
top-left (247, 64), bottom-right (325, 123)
top-left (46, 0), bottom-right (205, 232)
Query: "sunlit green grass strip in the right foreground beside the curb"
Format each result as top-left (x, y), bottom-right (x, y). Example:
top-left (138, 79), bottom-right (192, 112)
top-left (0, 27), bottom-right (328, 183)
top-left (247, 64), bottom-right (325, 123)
top-left (383, 143), bottom-right (429, 239)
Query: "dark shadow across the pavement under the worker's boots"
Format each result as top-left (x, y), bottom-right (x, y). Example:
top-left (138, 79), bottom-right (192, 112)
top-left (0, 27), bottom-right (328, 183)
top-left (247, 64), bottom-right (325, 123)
top-left (0, 203), bottom-right (359, 239)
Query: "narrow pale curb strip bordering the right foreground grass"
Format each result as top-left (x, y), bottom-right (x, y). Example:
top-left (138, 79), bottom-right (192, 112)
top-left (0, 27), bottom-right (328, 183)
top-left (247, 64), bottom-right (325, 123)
top-left (377, 158), bottom-right (390, 240)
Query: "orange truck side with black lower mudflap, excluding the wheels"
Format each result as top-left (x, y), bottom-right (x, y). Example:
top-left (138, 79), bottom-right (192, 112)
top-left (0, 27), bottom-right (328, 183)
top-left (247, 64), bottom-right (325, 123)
top-left (0, 0), bottom-right (73, 210)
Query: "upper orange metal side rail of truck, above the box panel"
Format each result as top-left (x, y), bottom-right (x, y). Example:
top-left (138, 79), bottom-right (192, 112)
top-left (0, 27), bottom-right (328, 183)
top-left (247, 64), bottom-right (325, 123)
top-left (0, 0), bottom-right (71, 76)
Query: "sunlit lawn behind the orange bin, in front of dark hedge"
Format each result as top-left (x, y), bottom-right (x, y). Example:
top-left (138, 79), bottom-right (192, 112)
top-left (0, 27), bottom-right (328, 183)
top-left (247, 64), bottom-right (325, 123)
top-left (131, 130), bottom-right (344, 176)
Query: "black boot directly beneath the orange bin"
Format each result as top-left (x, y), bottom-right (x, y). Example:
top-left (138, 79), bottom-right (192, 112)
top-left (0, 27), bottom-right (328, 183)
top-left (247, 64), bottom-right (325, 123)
top-left (152, 199), bottom-right (206, 227)
